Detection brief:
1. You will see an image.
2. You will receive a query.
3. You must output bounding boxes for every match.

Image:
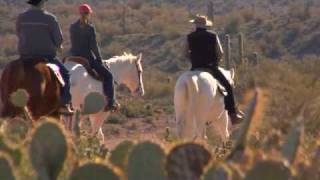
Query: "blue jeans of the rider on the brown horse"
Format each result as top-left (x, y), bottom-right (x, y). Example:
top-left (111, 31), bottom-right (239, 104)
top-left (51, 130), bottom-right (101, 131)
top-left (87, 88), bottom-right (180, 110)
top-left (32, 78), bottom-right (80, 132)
top-left (43, 56), bottom-right (71, 105)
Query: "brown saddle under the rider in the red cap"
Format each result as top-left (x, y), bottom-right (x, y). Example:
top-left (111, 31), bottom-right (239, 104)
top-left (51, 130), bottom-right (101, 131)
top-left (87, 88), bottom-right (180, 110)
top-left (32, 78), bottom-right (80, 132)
top-left (62, 56), bottom-right (103, 82)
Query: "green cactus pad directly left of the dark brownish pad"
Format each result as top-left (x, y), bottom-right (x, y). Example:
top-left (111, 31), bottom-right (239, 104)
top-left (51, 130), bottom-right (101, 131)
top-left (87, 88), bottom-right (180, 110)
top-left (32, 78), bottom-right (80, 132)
top-left (128, 142), bottom-right (166, 180)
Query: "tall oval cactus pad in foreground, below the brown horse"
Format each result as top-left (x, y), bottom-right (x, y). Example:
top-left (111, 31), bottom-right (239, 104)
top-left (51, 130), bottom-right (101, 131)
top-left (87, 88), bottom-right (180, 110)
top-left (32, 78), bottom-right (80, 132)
top-left (29, 121), bottom-right (68, 180)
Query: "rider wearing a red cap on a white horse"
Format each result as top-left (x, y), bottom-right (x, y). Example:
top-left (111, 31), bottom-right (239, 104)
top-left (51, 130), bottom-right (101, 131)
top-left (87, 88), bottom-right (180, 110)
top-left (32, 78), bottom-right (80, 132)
top-left (70, 4), bottom-right (120, 111)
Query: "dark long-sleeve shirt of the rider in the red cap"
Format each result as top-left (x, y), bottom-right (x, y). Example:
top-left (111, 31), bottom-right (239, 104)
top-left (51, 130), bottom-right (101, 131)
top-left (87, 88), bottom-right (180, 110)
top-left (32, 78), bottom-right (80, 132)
top-left (70, 20), bottom-right (101, 61)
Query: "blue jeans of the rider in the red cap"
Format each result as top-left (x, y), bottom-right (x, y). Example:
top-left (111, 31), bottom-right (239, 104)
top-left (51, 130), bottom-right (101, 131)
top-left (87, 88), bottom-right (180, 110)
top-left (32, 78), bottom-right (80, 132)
top-left (89, 60), bottom-right (115, 104)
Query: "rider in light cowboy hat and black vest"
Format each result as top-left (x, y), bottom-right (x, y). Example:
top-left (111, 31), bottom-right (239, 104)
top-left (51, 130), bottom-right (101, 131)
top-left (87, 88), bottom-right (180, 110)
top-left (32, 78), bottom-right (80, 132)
top-left (187, 15), bottom-right (243, 124)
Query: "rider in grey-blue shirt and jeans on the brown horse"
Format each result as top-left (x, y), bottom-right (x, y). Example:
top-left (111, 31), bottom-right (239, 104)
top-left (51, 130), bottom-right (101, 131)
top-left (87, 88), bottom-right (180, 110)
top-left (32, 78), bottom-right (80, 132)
top-left (16, 0), bottom-right (73, 114)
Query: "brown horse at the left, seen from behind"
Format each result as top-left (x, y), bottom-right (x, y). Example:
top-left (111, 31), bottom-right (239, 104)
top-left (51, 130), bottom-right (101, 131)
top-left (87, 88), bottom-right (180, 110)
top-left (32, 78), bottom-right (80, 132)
top-left (0, 58), bottom-right (61, 120)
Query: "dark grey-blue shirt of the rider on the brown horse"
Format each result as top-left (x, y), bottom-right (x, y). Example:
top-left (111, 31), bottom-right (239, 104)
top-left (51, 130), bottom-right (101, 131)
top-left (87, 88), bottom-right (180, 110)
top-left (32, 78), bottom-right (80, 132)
top-left (16, 8), bottom-right (63, 57)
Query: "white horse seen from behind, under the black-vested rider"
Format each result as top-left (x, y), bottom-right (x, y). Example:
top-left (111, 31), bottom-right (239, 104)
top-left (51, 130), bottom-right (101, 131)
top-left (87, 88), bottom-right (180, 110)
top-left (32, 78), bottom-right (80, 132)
top-left (174, 68), bottom-right (234, 141)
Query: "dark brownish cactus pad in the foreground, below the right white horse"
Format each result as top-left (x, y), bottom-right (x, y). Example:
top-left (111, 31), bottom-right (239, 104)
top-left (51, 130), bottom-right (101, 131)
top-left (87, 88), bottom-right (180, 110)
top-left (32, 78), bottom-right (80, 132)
top-left (166, 143), bottom-right (211, 180)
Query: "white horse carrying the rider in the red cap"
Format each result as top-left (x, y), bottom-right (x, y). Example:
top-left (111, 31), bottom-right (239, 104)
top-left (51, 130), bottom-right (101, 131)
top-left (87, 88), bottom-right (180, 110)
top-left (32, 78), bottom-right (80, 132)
top-left (64, 53), bottom-right (144, 142)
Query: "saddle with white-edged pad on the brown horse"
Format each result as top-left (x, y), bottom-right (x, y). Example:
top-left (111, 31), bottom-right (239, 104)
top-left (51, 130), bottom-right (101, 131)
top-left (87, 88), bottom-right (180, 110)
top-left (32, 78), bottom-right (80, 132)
top-left (18, 56), bottom-right (66, 87)
